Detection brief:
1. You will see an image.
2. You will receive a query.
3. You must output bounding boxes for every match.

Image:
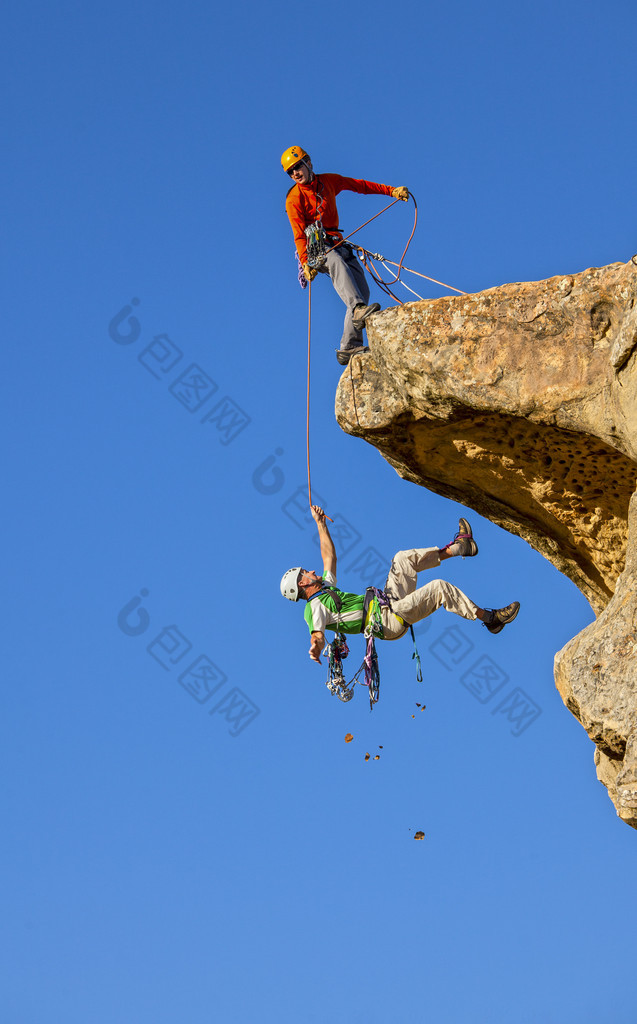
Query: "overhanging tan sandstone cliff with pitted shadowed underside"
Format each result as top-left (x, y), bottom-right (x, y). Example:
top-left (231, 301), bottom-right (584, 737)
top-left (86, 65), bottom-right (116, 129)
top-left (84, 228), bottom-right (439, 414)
top-left (336, 262), bottom-right (637, 827)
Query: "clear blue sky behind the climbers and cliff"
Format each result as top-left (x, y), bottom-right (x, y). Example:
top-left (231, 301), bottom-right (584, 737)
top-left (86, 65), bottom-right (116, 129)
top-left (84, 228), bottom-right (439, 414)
top-left (0, 0), bottom-right (637, 1024)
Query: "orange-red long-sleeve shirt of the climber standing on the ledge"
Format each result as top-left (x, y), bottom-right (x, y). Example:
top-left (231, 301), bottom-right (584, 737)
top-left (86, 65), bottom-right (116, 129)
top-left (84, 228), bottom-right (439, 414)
top-left (286, 174), bottom-right (392, 263)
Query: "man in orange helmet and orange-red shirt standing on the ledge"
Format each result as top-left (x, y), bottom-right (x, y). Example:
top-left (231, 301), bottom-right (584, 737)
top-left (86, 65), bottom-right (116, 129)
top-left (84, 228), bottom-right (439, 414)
top-left (281, 145), bottom-right (410, 367)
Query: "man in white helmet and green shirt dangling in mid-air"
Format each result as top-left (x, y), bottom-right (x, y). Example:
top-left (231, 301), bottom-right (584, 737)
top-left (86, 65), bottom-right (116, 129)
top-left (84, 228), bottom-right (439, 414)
top-left (281, 505), bottom-right (520, 665)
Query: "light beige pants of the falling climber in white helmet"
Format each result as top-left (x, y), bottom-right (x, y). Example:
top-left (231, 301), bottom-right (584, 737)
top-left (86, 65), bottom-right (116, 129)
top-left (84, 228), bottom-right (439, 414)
top-left (381, 548), bottom-right (477, 640)
